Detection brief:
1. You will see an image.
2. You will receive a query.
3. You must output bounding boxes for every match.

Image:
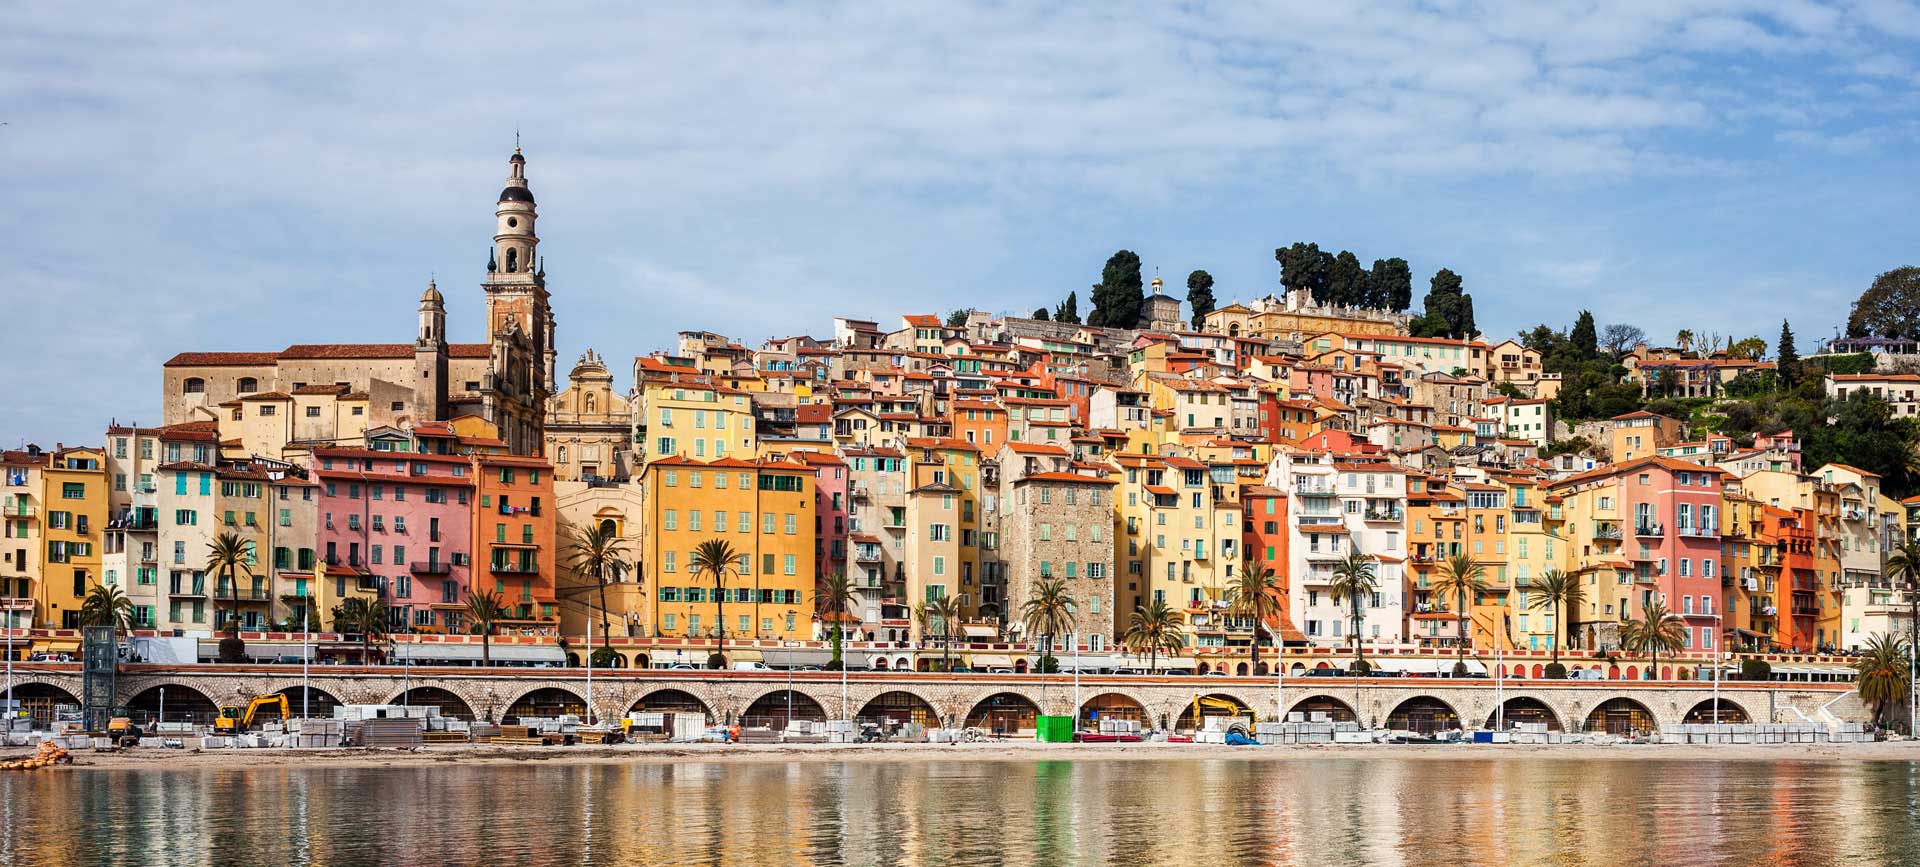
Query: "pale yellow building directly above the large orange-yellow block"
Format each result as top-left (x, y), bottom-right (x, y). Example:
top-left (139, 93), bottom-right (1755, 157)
top-left (636, 382), bottom-right (758, 466)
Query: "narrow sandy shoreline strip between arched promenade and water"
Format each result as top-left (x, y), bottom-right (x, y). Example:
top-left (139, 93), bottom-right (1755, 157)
top-left (26, 740), bottom-right (1920, 773)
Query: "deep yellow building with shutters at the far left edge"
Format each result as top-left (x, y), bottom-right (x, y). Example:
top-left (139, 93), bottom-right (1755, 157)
top-left (36, 449), bottom-right (108, 629)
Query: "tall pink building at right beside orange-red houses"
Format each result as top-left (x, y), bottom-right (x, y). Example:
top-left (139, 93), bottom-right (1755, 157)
top-left (1615, 458), bottom-right (1724, 650)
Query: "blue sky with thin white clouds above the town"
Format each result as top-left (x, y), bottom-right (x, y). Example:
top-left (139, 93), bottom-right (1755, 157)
top-left (0, 0), bottom-right (1920, 447)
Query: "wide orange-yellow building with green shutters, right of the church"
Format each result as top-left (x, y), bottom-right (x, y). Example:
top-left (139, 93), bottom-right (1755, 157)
top-left (639, 457), bottom-right (816, 641)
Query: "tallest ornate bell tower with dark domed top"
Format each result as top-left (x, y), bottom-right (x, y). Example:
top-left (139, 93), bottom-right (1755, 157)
top-left (480, 146), bottom-right (555, 455)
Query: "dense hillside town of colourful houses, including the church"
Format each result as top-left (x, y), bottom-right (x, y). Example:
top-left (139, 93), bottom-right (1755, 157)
top-left (0, 150), bottom-right (1920, 677)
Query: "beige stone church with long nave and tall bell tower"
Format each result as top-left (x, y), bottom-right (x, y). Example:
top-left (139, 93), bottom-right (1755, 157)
top-left (161, 148), bottom-right (555, 457)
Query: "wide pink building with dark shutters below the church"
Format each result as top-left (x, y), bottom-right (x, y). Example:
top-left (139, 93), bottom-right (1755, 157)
top-left (313, 449), bottom-right (472, 633)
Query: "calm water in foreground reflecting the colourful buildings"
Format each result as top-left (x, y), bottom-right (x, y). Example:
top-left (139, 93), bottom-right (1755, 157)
top-left (0, 758), bottom-right (1920, 867)
